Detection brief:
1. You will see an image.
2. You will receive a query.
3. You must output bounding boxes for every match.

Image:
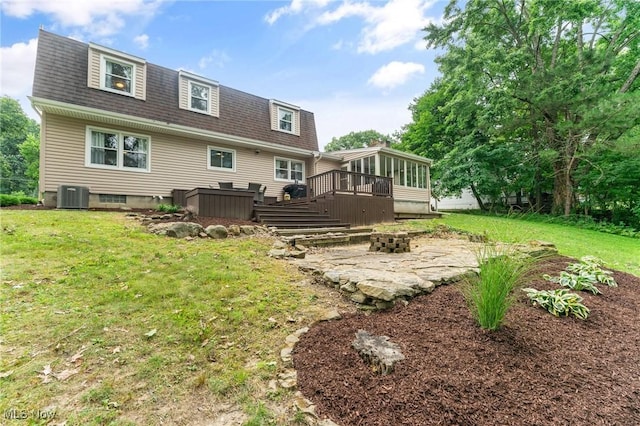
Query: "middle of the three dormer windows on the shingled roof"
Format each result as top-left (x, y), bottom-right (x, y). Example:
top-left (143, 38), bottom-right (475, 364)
top-left (178, 70), bottom-right (220, 117)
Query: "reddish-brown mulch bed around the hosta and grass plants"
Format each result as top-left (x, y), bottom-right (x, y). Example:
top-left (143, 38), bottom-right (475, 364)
top-left (293, 257), bottom-right (640, 426)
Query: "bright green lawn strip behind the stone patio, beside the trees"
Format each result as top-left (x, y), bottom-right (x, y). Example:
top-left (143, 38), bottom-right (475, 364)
top-left (380, 213), bottom-right (640, 276)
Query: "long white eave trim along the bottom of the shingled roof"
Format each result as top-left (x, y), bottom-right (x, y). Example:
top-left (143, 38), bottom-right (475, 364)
top-left (28, 96), bottom-right (318, 157)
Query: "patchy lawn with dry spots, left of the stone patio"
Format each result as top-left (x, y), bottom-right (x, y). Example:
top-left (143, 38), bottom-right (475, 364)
top-left (0, 210), bottom-right (324, 425)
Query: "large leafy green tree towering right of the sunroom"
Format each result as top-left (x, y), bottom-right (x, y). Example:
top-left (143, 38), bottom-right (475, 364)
top-left (400, 0), bottom-right (640, 214)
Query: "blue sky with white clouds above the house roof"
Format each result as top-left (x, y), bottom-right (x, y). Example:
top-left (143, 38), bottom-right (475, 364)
top-left (0, 0), bottom-right (446, 148)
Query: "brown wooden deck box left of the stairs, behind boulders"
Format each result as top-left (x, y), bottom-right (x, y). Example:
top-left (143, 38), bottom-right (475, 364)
top-left (185, 188), bottom-right (254, 220)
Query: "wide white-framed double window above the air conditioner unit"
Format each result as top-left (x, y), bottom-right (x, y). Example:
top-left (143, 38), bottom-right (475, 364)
top-left (86, 128), bottom-right (151, 171)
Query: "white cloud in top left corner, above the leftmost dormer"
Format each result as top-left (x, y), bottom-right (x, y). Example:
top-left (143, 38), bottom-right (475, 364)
top-left (2, 0), bottom-right (166, 38)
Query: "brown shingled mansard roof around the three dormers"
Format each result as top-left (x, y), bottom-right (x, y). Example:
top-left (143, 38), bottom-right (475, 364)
top-left (33, 30), bottom-right (318, 151)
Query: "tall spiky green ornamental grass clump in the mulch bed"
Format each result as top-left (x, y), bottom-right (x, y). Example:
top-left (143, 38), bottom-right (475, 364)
top-left (463, 245), bottom-right (536, 330)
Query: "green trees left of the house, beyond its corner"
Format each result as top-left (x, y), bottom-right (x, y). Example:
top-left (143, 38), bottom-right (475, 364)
top-left (0, 96), bottom-right (40, 194)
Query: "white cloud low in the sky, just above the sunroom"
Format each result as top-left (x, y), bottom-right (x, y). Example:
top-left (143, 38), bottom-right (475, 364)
top-left (295, 94), bottom-right (411, 150)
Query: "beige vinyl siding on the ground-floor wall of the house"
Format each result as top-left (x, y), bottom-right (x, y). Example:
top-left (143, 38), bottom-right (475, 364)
top-left (41, 113), bottom-right (312, 197)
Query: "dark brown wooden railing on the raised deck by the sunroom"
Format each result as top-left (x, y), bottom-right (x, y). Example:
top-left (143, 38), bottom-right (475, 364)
top-left (307, 170), bottom-right (393, 199)
